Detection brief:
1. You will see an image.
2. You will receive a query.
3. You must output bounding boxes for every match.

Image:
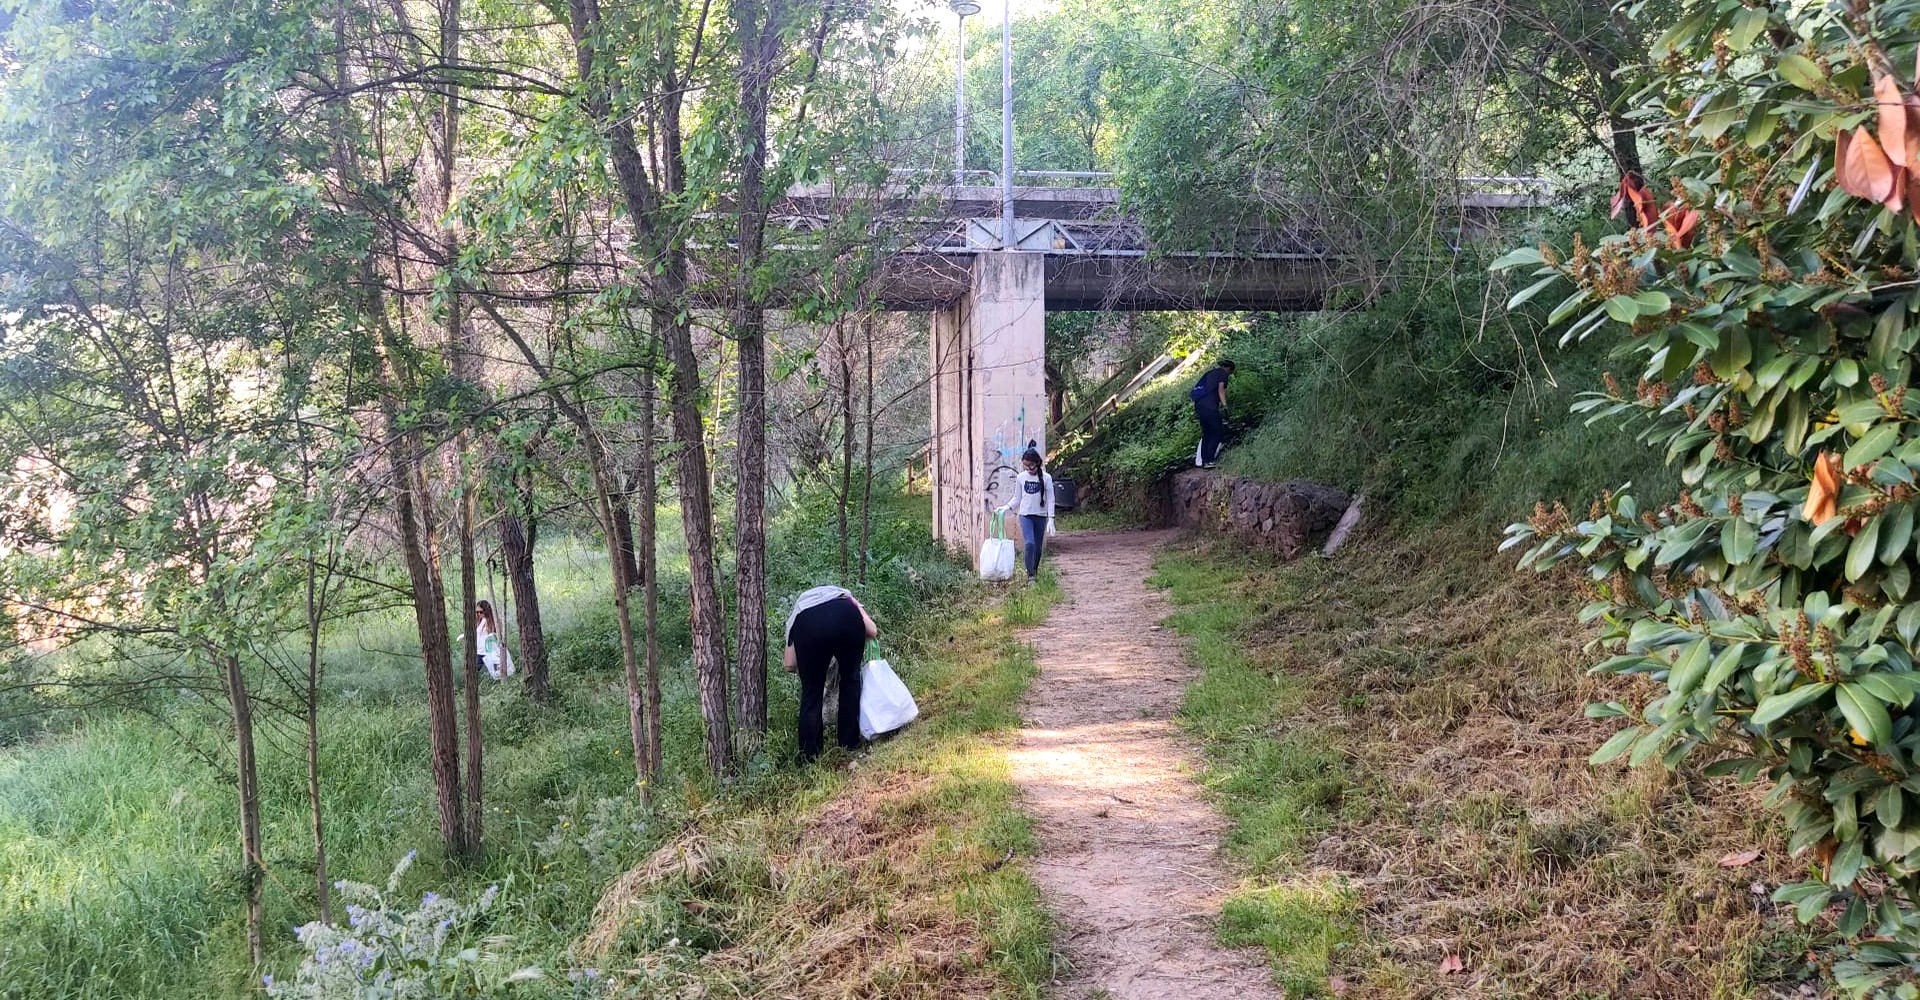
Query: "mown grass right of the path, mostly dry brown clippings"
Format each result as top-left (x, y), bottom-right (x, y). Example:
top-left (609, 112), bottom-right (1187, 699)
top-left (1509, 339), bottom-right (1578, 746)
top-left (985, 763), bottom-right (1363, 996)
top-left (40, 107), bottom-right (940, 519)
top-left (1154, 528), bottom-right (1809, 1000)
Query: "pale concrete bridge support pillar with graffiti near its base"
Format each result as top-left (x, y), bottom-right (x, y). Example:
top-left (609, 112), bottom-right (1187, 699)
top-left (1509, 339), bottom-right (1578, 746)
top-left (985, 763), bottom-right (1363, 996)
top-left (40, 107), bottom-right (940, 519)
top-left (929, 251), bottom-right (1046, 551)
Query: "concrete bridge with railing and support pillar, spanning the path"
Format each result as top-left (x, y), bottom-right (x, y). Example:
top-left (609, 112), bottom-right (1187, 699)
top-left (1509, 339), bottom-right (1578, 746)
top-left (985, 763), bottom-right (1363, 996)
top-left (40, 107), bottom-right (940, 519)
top-left (770, 171), bottom-right (1546, 551)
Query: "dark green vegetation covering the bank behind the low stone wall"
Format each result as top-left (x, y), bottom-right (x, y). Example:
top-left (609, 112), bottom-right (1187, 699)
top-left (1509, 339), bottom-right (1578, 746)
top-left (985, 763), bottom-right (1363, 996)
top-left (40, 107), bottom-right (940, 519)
top-left (1071, 261), bottom-right (1678, 528)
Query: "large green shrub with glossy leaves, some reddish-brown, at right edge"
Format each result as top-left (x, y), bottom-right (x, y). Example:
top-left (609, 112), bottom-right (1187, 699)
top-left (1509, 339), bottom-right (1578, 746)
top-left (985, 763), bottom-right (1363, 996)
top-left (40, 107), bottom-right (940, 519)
top-left (1500, 0), bottom-right (1920, 996)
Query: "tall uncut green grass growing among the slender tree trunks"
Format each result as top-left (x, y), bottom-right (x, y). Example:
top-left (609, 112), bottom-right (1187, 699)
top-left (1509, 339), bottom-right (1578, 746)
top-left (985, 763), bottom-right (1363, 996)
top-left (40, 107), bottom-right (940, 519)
top-left (0, 479), bottom-right (1044, 1000)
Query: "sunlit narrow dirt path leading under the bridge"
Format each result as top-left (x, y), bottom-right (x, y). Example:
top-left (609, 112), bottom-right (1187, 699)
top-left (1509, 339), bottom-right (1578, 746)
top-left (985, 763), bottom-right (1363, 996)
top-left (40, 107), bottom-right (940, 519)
top-left (1014, 532), bottom-right (1281, 1000)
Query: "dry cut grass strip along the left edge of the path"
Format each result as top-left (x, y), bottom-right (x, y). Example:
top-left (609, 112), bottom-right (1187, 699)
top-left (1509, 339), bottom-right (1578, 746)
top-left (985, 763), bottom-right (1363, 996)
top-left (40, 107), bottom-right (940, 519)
top-left (578, 591), bottom-right (1052, 1000)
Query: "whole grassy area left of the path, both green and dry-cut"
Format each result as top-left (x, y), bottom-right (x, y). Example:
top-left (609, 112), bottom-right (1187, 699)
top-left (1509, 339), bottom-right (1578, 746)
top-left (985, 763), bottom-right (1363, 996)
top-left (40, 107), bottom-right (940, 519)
top-left (0, 487), bottom-right (1050, 1000)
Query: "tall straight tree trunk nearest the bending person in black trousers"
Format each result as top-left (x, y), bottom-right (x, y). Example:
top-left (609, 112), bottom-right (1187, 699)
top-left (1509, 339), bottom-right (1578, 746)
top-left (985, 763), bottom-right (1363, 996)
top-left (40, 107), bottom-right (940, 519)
top-left (733, 0), bottom-right (783, 754)
